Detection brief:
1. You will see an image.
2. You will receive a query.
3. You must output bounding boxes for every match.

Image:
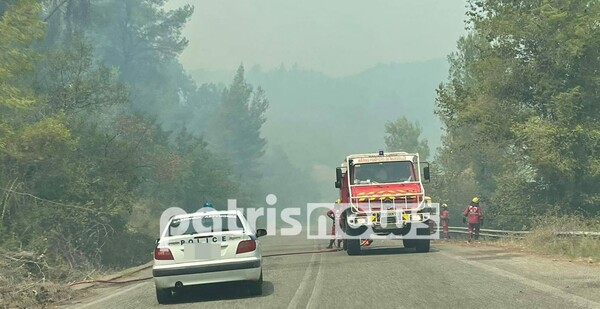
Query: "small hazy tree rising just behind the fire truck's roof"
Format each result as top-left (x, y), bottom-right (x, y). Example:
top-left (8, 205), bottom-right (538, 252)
top-left (384, 116), bottom-right (429, 159)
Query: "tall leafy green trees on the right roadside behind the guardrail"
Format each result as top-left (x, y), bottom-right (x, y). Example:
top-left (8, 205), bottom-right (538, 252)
top-left (437, 1), bottom-right (600, 225)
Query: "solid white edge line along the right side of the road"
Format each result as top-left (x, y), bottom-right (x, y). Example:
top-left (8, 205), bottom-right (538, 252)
top-left (440, 251), bottom-right (600, 308)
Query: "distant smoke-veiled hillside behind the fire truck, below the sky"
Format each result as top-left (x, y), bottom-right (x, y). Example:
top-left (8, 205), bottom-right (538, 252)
top-left (191, 59), bottom-right (448, 196)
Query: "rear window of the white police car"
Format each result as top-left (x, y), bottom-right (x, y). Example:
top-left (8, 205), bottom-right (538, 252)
top-left (169, 214), bottom-right (244, 236)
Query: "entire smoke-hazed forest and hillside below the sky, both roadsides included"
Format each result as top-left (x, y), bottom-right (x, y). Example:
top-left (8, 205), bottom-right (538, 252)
top-left (0, 0), bottom-right (600, 306)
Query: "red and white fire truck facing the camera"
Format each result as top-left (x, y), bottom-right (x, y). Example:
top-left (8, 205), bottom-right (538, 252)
top-left (335, 151), bottom-right (435, 255)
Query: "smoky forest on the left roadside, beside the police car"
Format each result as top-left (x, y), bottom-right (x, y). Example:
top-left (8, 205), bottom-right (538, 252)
top-left (0, 0), bottom-right (300, 292)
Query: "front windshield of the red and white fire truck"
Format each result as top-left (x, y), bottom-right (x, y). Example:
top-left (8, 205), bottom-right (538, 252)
top-left (353, 161), bottom-right (415, 184)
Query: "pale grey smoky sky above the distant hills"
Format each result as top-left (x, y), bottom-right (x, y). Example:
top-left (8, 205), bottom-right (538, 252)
top-left (167, 0), bottom-right (466, 76)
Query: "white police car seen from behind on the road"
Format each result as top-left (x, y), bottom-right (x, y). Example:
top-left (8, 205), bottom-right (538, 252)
top-left (152, 209), bottom-right (267, 303)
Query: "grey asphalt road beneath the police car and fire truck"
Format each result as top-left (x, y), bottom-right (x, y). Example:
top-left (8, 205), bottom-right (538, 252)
top-left (65, 236), bottom-right (600, 309)
